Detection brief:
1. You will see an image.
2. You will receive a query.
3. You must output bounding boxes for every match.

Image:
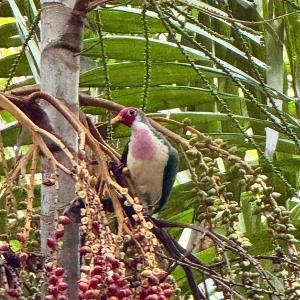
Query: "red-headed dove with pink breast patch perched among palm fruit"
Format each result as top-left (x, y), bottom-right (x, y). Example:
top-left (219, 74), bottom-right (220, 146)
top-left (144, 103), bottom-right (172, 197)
top-left (111, 107), bottom-right (179, 214)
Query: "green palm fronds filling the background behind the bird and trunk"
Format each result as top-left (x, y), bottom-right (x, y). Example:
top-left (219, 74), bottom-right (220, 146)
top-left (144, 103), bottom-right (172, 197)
top-left (0, 0), bottom-right (300, 299)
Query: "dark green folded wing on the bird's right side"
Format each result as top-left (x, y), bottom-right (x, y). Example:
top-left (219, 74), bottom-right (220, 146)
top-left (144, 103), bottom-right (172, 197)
top-left (155, 147), bottom-right (179, 212)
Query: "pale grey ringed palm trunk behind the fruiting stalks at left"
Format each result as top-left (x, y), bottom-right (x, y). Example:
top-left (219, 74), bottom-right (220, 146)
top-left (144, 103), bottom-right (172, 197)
top-left (41, 0), bottom-right (84, 300)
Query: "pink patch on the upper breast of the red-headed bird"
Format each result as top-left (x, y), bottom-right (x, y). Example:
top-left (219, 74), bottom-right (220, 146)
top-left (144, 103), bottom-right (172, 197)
top-left (130, 129), bottom-right (155, 160)
